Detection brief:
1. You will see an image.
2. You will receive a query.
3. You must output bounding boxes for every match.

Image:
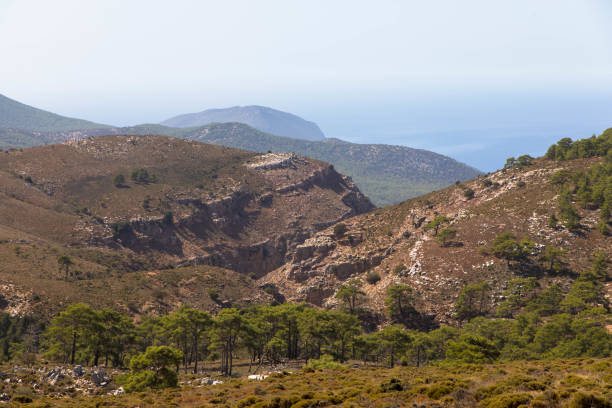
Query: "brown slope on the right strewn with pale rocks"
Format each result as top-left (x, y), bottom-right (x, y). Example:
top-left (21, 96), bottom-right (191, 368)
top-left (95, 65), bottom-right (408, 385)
top-left (260, 130), bottom-right (612, 328)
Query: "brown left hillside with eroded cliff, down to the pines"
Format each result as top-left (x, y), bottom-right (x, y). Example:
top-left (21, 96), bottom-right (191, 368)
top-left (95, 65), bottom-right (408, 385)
top-left (0, 136), bottom-right (374, 316)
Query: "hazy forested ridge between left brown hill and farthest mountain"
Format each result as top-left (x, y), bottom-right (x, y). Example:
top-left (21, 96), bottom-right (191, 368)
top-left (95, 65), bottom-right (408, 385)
top-left (185, 120), bottom-right (480, 206)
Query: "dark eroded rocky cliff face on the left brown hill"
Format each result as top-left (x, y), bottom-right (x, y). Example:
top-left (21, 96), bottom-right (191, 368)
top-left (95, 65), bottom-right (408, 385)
top-left (68, 142), bottom-right (375, 277)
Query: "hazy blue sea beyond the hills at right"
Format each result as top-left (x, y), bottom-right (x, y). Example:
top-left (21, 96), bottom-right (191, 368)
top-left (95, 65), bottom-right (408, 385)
top-left (308, 91), bottom-right (612, 172)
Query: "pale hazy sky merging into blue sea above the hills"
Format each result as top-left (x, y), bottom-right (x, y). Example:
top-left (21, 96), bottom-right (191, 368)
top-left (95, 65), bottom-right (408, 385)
top-left (0, 0), bottom-right (612, 171)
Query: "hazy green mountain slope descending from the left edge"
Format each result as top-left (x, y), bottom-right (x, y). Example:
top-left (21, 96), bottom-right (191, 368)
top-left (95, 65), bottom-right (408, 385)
top-left (0, 94), bottom-right (110, 133)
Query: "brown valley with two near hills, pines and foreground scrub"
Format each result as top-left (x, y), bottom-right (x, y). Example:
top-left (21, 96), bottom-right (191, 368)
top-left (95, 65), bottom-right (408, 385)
top-left (0, 125), bottom-right (612, 407)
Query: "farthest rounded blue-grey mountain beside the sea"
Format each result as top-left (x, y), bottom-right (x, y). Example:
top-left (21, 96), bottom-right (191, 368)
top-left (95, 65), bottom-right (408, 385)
top-left (161, 105), bottom-right (325, 140)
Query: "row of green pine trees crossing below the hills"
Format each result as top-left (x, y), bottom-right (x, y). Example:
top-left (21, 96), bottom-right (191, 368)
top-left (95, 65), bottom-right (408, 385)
top-left (0, 249), bottom-right (596, 375)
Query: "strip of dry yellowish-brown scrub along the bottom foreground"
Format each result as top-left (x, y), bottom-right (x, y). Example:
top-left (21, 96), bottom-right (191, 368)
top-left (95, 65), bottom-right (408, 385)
top-left (5, 359), bottom-right (612, 408)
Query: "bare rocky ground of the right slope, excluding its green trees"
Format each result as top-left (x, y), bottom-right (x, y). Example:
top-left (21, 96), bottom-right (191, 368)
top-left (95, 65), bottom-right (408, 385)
top-left (260, 156), bottom-right (612, 324)
